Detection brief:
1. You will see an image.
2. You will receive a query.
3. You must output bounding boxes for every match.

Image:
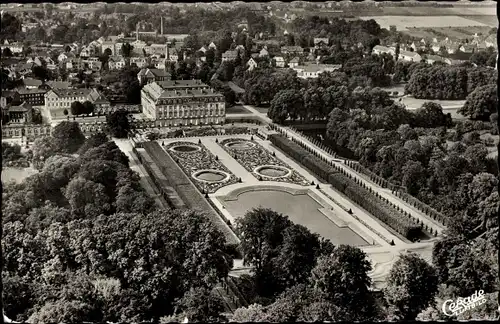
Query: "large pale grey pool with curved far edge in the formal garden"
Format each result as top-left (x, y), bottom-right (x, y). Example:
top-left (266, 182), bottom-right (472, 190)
top-left (222, 189), bottom-right (369, 246)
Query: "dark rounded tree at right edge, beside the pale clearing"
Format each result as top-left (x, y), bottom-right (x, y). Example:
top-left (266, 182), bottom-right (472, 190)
top-left (458, 84), bottom-right (498, 121)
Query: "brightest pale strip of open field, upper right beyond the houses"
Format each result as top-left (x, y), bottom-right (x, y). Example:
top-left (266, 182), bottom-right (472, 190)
top-left (359, 16), bottom-right (486, 30)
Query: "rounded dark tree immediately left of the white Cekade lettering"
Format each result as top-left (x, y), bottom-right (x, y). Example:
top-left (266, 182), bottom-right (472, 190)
top-left (385, 253), bottom-right (438, 321)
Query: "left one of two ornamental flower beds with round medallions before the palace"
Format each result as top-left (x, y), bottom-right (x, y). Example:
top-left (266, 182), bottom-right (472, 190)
top-left (165, 142), bottom-right (238, 193)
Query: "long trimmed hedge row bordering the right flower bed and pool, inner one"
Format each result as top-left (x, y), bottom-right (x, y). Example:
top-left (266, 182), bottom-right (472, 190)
top-left (269, 134), bottom-right (422, 240)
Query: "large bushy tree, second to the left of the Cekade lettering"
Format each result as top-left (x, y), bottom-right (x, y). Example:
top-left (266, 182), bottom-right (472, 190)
top-left (310, 245), bottom-right (376, 321)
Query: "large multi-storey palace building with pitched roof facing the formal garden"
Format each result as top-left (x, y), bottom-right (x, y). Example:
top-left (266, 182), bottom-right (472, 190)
top-left (141, 80), bottom-right (226, 126)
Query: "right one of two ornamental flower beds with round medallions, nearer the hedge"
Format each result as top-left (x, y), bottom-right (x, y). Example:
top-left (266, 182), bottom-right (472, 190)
top-left (219, 138), bottom-right (309, 186)
